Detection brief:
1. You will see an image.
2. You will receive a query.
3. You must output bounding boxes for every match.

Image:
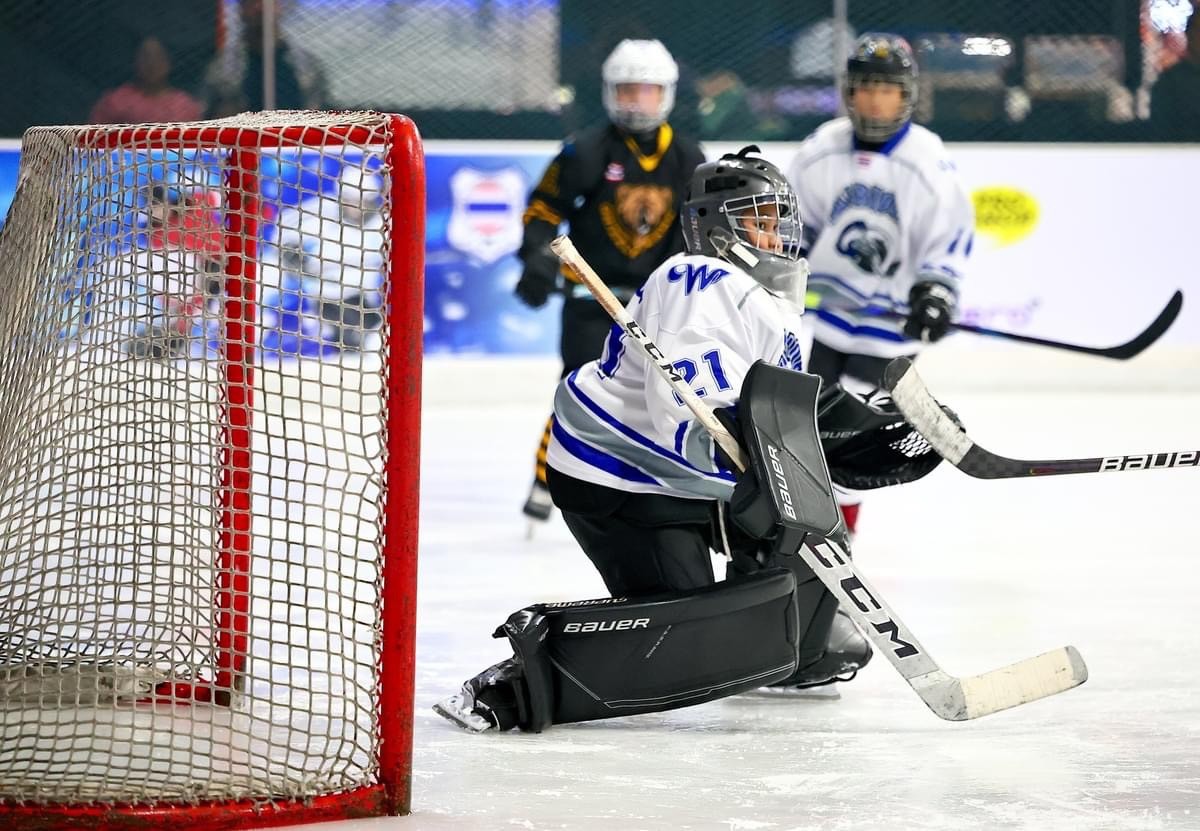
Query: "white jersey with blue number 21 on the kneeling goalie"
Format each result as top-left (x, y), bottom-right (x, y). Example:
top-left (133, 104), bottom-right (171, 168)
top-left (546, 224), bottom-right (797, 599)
top-left (547, 255), bottom-right (802, 500)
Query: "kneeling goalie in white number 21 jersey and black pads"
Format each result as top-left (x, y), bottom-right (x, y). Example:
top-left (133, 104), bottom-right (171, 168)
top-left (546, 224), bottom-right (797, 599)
top-left (433, 148), bottom-right (960, 733)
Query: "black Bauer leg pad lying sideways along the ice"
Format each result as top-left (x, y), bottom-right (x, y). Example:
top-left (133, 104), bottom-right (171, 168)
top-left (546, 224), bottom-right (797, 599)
top-left (497, 568), bottom-right (799, 731)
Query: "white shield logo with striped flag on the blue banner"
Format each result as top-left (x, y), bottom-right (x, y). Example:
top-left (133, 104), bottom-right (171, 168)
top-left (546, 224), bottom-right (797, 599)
top-left (446, 167), bottom-right (526, 263)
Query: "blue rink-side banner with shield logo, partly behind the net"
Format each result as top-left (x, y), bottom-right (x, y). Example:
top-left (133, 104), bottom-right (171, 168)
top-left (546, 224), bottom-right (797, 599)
top-left (0, 142), bottom-right (562, 357)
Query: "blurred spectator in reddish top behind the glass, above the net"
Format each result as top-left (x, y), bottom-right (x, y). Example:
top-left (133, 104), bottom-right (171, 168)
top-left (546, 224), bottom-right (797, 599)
top-left (89, 36), bottom-right (203, 124)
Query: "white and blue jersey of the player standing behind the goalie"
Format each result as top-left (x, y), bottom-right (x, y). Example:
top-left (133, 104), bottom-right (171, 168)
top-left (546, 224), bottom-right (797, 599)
top-left (788, 118), bottom-right (974, 358)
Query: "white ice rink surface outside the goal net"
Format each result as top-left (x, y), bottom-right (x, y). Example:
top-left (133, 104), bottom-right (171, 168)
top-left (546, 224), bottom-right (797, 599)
top-left (312, 349), bottom-right (1200, 831)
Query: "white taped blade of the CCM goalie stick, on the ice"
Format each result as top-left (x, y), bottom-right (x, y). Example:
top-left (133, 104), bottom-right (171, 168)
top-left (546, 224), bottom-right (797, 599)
top-left (950, 646), bottom-right (1087, 721)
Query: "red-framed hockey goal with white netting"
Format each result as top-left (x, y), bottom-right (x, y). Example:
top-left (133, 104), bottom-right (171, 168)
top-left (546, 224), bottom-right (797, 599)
top-left (0, 112), bottom-right (425, 827)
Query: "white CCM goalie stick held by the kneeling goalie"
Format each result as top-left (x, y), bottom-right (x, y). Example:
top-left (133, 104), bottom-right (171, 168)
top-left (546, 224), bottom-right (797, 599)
top-left (550, 237), bottom-right (1087, 722)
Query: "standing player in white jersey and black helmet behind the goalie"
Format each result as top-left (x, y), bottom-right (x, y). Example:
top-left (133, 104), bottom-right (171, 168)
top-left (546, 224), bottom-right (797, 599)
top-left (788, 34), bottom-right (974, 532)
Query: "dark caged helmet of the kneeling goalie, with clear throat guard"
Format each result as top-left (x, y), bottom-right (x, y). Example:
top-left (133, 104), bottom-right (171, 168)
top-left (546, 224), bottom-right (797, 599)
top-left (683, 144), bottom-right (808, 309)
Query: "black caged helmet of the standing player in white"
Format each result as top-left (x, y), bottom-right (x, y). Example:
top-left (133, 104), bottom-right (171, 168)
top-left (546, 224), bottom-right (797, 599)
top-left (841, 32), bottom-right (917, 143)
